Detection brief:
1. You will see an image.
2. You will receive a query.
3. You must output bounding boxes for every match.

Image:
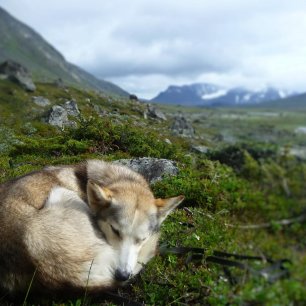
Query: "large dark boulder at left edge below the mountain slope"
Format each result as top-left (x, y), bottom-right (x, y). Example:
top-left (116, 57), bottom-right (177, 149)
top-left (0, 60), bottom-right (36, 91)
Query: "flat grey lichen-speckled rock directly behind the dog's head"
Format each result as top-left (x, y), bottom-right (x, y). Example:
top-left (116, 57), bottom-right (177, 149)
top-left (114, 157), bottom-right (179, 184)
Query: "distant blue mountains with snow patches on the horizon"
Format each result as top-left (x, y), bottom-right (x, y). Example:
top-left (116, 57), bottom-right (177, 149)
top-left (151, 83), bottom-right (292, 106)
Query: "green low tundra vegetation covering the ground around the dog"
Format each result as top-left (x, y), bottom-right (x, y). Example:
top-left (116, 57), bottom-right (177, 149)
top-left (0, 80), bottom-right (306, 305)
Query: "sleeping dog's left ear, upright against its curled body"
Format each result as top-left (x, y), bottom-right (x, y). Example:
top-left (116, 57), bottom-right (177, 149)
top-left (87, 180), bottom-right (113, 213)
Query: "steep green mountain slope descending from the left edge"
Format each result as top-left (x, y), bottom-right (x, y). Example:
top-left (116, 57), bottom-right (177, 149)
top-left (0, 7), bottom-right (128, 96)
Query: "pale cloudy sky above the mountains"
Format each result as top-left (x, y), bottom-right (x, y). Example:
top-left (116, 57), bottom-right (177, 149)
top-left (0, 0), bottom-right (306, 98)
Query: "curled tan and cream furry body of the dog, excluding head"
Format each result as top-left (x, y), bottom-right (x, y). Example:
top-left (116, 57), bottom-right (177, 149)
top-left (0, 160), bottom-right (146, 292)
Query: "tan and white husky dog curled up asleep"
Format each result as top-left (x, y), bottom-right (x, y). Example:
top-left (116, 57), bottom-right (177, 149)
top-left (0, 160), bottom-right (183, 293)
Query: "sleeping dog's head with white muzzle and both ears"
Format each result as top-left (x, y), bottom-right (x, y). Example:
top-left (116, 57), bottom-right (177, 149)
top-left (87, 180), bottom-right (184, 281)
